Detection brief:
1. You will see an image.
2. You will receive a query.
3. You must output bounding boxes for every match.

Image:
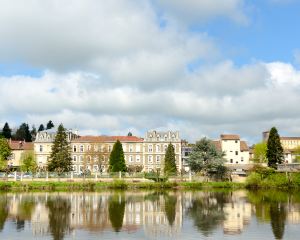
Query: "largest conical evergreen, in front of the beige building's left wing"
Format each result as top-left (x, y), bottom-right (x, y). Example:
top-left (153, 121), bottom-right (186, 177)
top-left (48, 124), bottom-right (72, 174)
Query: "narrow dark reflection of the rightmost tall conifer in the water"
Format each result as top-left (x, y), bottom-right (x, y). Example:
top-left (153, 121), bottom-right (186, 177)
top-left (270, 203), bottom-right (286, 239)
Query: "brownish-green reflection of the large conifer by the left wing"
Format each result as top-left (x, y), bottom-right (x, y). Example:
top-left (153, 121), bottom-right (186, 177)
top-left (47, 197), bottom-right (71, 240)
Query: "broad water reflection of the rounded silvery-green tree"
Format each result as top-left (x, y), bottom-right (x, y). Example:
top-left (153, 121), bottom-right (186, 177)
top-left (187, 192), bottom-right (226, 236)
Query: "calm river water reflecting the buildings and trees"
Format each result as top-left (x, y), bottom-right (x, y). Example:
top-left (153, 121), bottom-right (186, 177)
top-left (0, 191), bottom-right (300, 240)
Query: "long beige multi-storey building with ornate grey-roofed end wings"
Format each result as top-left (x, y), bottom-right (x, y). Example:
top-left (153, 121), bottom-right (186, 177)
top-left (34, 130), bottom-right (181, 173)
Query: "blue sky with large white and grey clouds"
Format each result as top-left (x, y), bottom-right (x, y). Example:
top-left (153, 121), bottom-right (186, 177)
top-left (0, 0), bottom-right (300, 143)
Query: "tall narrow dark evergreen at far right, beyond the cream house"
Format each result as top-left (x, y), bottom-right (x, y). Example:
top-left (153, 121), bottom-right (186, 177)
top-left (267, 127), bottom-right (284, 168)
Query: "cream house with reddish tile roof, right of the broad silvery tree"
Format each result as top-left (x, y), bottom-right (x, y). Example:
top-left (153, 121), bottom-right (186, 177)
top-left (214, 134), bottom-right (250, 164)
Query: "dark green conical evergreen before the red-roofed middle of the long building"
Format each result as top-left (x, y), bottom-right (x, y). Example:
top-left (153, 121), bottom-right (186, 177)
top-left (109, 140), bottom-right (127, 172)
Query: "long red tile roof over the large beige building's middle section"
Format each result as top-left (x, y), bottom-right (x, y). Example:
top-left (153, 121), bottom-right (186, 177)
top-left (72, 136), bottom-right (143, 142)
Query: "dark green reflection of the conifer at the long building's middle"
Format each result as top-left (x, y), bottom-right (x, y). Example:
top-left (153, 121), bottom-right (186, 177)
top-left (108, 194), bottom-right (125, 232)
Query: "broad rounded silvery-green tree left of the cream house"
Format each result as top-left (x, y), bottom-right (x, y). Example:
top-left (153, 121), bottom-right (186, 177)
top-left (187, 138), bottom-right (226, 175)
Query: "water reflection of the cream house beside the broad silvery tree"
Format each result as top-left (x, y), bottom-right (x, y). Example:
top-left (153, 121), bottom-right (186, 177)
top-left (223, 191), bottom-right (251, 234)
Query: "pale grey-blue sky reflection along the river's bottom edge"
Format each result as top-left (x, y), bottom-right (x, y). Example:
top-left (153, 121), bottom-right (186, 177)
top-left (0, 193), bottom-right (300, 240)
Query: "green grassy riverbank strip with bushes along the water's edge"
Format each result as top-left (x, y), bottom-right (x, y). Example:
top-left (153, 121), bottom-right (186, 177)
top-left (0, 172), bottom-right (300, 191)
